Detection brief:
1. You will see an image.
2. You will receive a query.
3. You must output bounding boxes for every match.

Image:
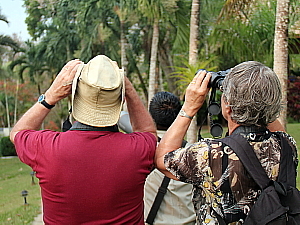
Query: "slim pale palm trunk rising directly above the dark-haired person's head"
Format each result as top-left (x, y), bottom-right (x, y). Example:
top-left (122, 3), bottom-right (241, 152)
top-left (148, 19), bottom-right (159, 106)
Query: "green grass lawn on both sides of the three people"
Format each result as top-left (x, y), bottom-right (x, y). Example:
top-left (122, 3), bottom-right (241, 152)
top-left (0, 123), bottom-right (300, 225)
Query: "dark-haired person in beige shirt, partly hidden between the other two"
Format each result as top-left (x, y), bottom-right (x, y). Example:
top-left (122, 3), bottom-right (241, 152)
top-left (144, 92), bottom-right (196, 225)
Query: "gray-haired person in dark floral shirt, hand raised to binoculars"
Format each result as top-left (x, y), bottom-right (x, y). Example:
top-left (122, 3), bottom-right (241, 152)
top-left (155, 61), bottom-right (297, 225)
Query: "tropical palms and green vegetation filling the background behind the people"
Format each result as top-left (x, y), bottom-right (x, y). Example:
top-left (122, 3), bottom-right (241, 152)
top-left (0, 0), bottom-right (300, 139)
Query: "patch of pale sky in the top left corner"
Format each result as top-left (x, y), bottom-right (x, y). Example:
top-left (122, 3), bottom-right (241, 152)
top-left (0, 0), bottom-right (30, 41)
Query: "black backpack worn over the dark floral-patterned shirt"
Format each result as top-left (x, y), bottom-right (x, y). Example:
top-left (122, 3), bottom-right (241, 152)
top-left (222, 134), bottom-right (300, 225)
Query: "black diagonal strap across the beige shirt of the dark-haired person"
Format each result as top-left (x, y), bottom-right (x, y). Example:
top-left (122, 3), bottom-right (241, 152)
top-left (146, 176), bottom-right (170, 224)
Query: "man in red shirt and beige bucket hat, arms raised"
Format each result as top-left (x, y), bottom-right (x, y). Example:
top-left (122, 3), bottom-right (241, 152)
top-left (10, 55), bottom-right (157, 225)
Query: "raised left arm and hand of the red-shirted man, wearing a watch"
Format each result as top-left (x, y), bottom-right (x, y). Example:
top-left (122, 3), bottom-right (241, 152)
top-left (10, 59), bottom-right (82, 143)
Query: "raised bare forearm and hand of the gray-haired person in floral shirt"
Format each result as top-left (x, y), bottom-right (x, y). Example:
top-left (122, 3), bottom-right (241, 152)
top-left (155, 71), bottom-right (211, 179)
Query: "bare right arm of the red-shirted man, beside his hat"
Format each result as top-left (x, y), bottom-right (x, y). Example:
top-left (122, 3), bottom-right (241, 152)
top-left (125, 77), bottom-right (157, 137)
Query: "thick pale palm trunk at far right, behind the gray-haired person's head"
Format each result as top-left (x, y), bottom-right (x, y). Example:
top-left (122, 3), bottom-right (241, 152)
top-left (273, 0), bottom-right (289, 127)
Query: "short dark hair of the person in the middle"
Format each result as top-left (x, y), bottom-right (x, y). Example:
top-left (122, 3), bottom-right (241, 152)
top-left (149, 91), bottom-right (181, 130)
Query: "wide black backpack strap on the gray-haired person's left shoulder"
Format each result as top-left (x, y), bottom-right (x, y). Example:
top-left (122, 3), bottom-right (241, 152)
top-left (222, 134), bottom-right (270, 189)
